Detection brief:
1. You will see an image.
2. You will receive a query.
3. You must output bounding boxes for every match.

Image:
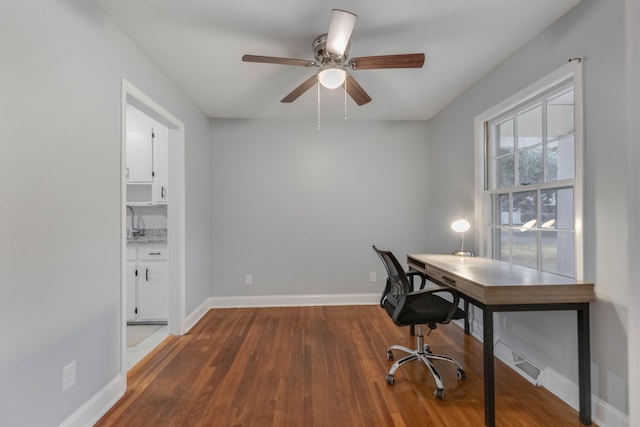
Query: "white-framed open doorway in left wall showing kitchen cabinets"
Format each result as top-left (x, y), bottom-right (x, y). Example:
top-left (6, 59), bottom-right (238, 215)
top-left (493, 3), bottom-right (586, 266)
top-left (121, 79), bottom-right (185, 379)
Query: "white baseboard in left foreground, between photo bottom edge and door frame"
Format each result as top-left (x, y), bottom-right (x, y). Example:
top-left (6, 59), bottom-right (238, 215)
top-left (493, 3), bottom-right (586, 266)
top-left (60, 374), bottom-right (126, 427)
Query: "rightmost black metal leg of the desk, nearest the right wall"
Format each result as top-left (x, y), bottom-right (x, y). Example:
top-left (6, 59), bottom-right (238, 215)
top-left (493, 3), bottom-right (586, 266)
top-left (578, 303), bottom-right (591, 425)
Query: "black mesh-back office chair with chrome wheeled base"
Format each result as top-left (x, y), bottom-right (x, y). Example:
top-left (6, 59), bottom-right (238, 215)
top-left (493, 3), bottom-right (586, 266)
top-left (373, 245), bottom-right (467, 400)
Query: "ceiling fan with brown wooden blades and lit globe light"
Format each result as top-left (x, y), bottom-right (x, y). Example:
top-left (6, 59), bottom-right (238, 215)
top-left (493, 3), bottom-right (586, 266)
top-left (242, 9), bottom-right (424, 105)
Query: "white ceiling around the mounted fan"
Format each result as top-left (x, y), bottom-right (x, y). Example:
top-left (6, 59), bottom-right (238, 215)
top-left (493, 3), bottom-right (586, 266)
top-left (96, 0), bottom-right (580, 120)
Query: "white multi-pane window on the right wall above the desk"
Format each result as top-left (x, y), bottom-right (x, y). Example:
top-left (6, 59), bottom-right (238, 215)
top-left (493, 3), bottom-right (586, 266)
top-left (476, 61), bottom-right (583, 278)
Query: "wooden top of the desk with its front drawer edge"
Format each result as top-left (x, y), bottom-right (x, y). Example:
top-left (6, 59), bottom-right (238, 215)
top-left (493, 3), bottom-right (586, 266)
top-left (407, 254), bottom-right (595, 304)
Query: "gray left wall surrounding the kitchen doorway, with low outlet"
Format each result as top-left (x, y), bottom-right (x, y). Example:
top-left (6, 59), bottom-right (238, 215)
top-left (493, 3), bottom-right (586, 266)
top-left (0, 0), bottom-right (211, 426)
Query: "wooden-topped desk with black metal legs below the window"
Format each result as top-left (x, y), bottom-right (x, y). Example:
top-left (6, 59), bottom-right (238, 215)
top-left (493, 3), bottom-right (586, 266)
top-left (407, 254), bottom-right (595, 427)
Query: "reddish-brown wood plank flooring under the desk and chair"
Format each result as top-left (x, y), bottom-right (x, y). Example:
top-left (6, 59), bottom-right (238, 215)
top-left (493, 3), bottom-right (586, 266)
top-left (97, 306), bottom-right (582, 427)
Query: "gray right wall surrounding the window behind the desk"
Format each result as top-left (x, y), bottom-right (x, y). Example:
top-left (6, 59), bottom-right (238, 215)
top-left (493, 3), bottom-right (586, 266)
top-left (429, 0), bottom-right (637, 414)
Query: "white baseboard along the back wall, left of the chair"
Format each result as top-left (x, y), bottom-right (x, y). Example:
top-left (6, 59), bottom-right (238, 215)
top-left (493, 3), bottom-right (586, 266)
top-left (209, 293), bottom-right (380, 308)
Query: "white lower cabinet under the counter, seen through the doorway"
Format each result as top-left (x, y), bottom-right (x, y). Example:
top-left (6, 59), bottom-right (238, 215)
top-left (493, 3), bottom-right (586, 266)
top-left (126, 245), bottom-right (169, 322)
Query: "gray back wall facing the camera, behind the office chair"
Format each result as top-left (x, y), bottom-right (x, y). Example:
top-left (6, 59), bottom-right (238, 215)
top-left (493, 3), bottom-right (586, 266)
top-left (211, 118), bottom-right (430, 296)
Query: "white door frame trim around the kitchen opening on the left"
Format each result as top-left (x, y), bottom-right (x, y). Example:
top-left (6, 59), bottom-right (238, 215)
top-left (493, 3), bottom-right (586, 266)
top-left (120, 79), bottom-right (186, 382)
